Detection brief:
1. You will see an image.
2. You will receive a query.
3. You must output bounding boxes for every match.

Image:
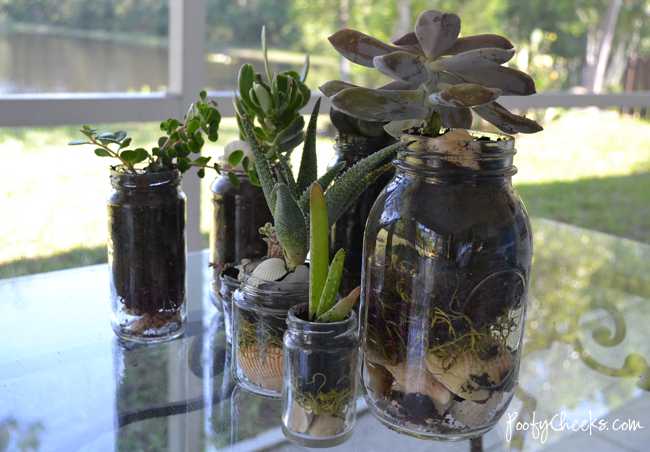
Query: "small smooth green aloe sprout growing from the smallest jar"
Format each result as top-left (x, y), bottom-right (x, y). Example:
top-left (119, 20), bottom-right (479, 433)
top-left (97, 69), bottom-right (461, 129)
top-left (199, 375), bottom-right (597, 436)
top-left (309, 183), bottom-right (361, 322)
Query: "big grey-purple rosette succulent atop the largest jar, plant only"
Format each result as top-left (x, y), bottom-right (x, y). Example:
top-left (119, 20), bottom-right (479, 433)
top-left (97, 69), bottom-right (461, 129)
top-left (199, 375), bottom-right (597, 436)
top-left (320, 10), bottom-right (542, 136)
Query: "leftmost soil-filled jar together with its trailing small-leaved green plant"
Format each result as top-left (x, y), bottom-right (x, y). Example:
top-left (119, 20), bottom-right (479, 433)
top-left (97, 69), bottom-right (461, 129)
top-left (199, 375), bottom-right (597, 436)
top-left (69, 92), bottom-right (233, 342)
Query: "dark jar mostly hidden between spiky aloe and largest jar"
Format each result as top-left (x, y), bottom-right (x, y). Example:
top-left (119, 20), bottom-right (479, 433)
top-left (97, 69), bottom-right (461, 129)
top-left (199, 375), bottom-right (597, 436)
top-left (327, 132), bottom-right (395, 297)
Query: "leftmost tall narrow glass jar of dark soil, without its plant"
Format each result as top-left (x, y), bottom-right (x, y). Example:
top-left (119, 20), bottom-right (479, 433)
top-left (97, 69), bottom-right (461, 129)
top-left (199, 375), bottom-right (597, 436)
top-left (107, 167), bottom-right (187, 342)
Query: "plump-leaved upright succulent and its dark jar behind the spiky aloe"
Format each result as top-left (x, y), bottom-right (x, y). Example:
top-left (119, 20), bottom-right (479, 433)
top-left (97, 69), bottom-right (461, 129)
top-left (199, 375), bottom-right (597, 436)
top-left (210, 28), bottom-right (311, 311)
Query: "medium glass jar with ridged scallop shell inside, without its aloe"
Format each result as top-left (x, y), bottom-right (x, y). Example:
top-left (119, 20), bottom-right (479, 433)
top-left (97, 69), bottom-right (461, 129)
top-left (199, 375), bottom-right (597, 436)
top-left (232, 262), bottom-right (309, 399)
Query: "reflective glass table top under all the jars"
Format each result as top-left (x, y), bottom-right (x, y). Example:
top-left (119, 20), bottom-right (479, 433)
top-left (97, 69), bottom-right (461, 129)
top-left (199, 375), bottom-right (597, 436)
top-left (0, 220), bottom-right (650, 452)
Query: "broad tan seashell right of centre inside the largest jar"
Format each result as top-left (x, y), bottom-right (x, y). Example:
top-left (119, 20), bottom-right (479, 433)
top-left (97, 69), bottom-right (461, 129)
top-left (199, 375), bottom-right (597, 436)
top-left (426, 351), bottom-right (515, 401)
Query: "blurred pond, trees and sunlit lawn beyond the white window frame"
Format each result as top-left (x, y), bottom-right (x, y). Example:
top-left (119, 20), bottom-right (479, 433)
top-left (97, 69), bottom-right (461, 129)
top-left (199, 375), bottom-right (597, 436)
top-left (0, 0), bottom-right (650, 278)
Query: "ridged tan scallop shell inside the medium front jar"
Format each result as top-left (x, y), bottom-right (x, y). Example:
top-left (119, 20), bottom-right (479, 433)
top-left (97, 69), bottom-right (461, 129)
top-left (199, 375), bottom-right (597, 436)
top-left (237, 345), bottom-right (283, 392)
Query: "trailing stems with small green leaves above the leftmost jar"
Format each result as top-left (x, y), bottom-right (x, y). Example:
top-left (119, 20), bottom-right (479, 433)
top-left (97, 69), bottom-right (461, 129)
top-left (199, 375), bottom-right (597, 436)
top-left (68, 91), bottom-right (228, 177)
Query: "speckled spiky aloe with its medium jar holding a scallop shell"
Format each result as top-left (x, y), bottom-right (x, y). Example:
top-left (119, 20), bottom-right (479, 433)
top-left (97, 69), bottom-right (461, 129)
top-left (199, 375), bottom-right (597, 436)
top-left (233, 91), bottom-right (406, 398)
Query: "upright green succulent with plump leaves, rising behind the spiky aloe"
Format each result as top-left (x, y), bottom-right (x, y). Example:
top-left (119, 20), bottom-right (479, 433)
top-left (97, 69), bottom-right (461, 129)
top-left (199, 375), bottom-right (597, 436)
top-left (233, 28), bottom-right (311, 166)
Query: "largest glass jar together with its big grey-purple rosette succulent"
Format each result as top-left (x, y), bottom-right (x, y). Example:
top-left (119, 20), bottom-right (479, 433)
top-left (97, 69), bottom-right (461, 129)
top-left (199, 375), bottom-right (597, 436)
top-left (321, 10), bottom-right (541, 440)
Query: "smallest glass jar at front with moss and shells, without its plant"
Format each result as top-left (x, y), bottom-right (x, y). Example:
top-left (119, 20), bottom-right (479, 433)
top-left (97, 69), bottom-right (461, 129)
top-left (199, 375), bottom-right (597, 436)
top-left (282, 303), bottom-right (359, 447)
